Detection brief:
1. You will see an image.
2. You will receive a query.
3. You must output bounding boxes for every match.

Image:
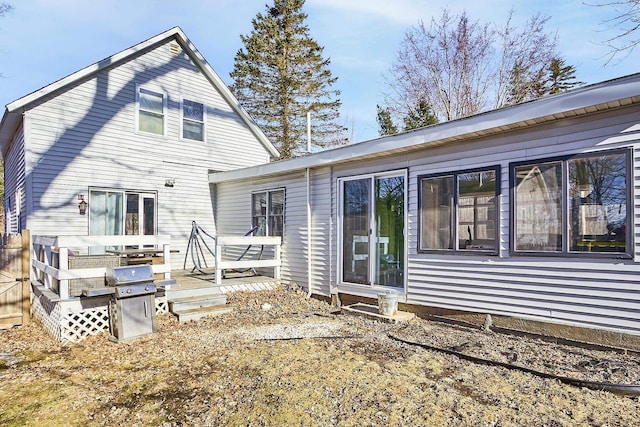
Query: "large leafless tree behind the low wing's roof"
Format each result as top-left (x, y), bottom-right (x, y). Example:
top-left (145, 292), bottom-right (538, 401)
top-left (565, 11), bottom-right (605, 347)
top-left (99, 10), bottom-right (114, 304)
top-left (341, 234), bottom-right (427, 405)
top-left (386, 10), bottom-right (558, 121)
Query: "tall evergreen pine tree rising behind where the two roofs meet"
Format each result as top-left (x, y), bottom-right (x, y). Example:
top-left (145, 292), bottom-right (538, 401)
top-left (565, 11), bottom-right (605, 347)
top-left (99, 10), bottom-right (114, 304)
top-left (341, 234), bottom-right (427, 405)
top-left (230, 0), bottom-right (346, 158)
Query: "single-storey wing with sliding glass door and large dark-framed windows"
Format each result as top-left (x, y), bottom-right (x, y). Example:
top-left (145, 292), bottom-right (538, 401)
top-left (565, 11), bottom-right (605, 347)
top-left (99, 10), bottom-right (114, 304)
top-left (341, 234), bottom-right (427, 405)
top-left (210, 74), bottom-right (640, 342)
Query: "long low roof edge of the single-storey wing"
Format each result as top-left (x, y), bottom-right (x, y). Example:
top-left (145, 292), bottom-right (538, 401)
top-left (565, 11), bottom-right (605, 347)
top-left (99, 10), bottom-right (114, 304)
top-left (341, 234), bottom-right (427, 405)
top-left (209, 73), bottom-right (640, 183)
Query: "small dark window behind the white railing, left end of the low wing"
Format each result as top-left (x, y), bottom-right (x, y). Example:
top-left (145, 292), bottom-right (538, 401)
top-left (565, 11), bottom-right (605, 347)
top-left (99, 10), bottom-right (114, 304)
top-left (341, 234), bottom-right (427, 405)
top-left (251, 189), bottom-right (284, 237)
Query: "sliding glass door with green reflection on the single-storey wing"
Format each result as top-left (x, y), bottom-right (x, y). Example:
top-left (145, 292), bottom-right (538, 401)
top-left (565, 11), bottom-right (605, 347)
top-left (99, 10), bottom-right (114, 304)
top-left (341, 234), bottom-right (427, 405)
top-left (339, 172), bottom-right (406, 288)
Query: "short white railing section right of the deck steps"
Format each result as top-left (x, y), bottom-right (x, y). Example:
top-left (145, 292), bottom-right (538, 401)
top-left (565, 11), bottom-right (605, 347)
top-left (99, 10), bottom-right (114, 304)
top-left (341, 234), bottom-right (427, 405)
top-left (215, 236), bottom-right (282, 284)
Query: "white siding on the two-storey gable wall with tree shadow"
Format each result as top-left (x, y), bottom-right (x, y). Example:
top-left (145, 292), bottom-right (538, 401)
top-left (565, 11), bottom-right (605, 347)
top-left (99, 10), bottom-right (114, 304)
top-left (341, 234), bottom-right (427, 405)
top-left (17, 36), bottom-right (269, 268)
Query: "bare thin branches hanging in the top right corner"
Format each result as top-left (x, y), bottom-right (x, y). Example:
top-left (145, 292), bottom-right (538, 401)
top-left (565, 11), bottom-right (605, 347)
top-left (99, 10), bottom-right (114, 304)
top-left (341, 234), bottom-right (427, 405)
top-left (587, 0), bottom-right (640, 64)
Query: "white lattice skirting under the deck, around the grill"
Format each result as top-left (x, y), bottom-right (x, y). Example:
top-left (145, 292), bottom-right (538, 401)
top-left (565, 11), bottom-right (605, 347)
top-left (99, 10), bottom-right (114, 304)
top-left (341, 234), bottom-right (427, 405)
top-left (31, 289), bottom-right (169, 343)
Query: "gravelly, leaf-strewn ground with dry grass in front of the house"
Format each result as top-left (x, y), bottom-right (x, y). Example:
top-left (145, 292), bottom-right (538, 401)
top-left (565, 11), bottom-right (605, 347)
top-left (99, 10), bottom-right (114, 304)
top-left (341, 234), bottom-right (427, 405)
top-left (0, 287), bottom-right (640, 426)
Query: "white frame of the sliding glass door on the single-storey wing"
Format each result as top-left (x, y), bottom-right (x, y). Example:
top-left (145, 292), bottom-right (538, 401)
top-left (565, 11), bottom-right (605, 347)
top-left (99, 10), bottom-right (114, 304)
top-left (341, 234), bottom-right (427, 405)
top-left (336, 169), bottom-right (409, 294)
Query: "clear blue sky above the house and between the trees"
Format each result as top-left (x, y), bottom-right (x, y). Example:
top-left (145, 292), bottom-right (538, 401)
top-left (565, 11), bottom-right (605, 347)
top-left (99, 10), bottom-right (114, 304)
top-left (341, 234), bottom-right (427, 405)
top-left (0, 0), bottom-right (640, 141)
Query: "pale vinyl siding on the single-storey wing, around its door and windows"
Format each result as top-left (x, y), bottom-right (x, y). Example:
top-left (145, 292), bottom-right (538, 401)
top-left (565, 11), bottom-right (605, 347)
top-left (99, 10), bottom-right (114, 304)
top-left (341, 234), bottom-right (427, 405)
top-left (217, 102), bottom-right (640, 334)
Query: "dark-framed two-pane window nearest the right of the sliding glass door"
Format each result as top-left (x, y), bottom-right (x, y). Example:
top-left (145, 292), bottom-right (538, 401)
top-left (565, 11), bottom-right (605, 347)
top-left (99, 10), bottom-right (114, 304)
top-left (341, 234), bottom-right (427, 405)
top-left (418, 166), bottom-right (500, 253)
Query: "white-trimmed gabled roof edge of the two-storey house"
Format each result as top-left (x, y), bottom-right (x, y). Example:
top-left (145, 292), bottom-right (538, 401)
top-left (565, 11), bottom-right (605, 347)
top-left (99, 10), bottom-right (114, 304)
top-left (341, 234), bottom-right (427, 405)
top-left (0, 27), bottom-right (279, 158)
